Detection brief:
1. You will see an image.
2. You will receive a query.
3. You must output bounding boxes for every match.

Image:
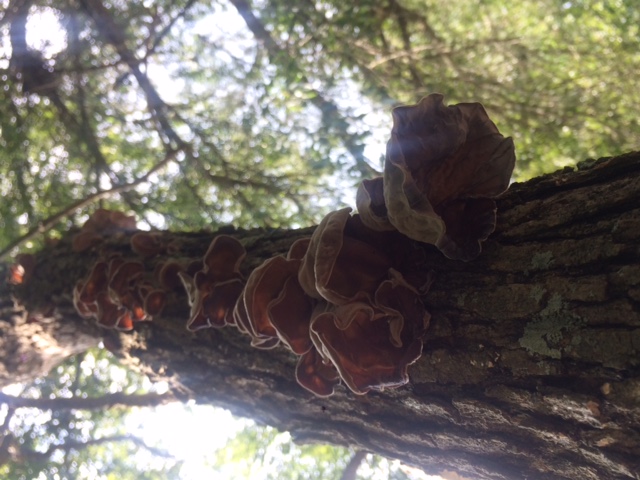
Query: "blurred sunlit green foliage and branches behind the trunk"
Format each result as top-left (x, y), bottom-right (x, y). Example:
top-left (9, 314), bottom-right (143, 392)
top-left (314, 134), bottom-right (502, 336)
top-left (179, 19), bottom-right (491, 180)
top-left (0, 0), bottom-right (640, 478)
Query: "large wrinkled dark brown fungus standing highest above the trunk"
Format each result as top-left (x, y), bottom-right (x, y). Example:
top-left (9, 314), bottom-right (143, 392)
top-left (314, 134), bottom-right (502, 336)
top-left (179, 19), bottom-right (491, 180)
top-left (384, 94), bottom-right (515, 261)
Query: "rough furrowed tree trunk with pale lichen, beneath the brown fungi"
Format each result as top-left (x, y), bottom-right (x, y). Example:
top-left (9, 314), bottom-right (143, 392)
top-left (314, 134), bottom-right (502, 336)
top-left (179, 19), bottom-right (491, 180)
top-left (5, 153), bottom-right (640, 479)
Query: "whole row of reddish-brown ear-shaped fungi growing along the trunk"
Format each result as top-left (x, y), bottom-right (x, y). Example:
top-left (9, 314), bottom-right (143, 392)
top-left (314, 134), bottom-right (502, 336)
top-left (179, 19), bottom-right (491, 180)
top-left (74, 94), bottom-right (515, 396)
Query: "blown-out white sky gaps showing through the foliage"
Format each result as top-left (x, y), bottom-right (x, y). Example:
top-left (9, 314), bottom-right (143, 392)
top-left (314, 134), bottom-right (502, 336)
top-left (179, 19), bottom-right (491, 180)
top-left (10, 7), bottom-right (441, 480)
